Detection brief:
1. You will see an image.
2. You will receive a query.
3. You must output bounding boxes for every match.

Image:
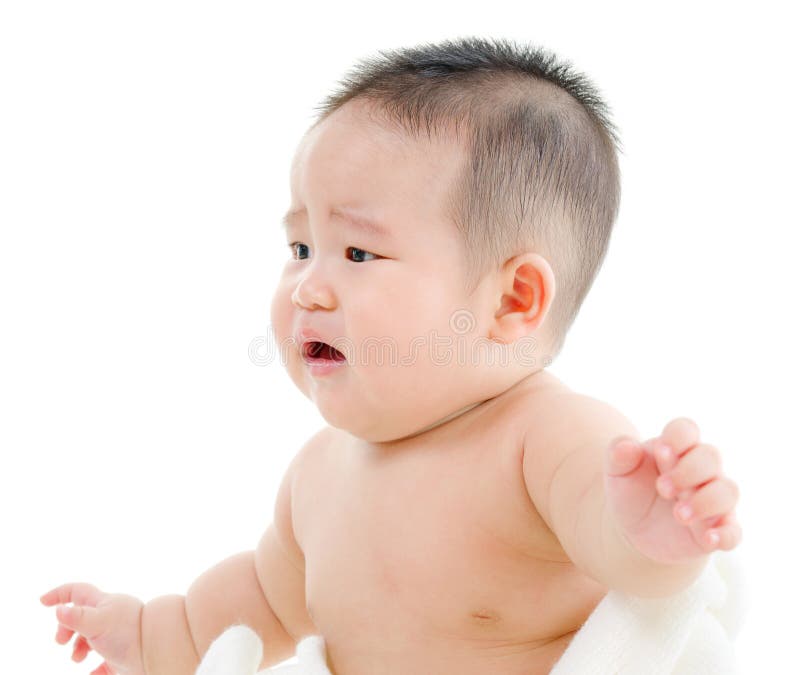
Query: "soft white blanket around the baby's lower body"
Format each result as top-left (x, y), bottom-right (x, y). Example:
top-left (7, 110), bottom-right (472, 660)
top-left (195, 550), bottom-right (745, 675)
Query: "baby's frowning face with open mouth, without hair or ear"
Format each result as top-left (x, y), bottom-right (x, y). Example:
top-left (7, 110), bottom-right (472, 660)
top-left (271, 103), bottom-right (500, 441)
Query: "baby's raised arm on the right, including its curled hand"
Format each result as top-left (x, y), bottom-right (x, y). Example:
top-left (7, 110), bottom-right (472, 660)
top-left (523, 393), bottom-right (738, 597)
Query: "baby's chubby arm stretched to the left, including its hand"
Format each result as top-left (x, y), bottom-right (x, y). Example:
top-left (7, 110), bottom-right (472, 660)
top-left (42, 434), bottom-right (320, 675)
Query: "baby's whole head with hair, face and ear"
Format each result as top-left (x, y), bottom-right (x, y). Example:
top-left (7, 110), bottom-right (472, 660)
top-left (272, 38), bottom-right (620, 442)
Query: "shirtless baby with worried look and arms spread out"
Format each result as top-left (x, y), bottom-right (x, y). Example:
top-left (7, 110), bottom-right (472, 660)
top-left (42, 38), bottom-right (741, 675)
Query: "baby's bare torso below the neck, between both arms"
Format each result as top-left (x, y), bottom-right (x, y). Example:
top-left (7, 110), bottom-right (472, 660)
top-left (295, 414), bottom-right (604, 675)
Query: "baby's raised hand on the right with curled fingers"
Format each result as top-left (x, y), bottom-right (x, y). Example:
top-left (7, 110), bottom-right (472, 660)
top-left (605, 417), bottom-right (742, 563)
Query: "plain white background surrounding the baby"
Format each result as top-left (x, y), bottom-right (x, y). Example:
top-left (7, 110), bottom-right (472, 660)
top-left (0, 0), bottom-right (800, 673)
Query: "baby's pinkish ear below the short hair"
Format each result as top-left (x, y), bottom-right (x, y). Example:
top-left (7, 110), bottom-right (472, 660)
top-left (489, 253), bottom-right (556, 344)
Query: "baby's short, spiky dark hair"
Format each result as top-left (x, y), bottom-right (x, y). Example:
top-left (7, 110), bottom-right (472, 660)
top-left (306, 37), bottom-right (620, 359)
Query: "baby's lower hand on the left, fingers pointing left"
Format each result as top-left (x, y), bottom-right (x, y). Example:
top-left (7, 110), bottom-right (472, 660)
top-left (40, 583), bottom-right (146, 675)
